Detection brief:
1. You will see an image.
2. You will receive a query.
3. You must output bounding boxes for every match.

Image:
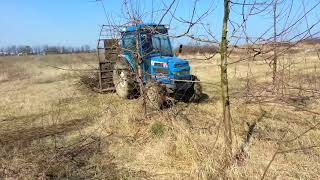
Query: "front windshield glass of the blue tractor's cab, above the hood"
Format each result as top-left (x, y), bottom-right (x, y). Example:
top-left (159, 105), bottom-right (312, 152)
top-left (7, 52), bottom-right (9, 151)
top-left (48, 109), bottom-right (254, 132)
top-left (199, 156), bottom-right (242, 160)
top-left (141, 33), bottom-right (173, 56)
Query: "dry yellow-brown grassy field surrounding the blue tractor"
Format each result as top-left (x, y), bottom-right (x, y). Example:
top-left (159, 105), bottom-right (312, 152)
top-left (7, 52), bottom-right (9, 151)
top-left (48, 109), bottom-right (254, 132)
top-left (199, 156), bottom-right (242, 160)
top-left (0, 54), bottom-right (320, 179)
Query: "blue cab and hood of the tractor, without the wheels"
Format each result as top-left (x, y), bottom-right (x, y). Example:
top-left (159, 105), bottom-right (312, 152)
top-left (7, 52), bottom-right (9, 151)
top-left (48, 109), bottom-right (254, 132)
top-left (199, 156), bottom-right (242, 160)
top-left (120, 24), bottom-right (190, 89)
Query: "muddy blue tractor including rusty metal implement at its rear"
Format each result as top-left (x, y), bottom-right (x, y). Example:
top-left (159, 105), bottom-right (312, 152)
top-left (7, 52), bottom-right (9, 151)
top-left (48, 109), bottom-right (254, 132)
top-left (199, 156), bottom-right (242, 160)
top-left (97, 24), bottom-right (202, 108)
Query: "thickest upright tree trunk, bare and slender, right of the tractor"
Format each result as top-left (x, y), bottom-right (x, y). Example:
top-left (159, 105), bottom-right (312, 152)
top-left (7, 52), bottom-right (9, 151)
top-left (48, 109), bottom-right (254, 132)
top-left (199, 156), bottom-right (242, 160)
top-left (220, 0), bottom-right (232, 166)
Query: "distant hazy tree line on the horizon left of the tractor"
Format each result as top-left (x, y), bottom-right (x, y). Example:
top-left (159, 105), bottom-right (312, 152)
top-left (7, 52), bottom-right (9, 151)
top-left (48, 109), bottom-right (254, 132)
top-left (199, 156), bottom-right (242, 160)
top-left (0, 45), bottom-right (95, 56)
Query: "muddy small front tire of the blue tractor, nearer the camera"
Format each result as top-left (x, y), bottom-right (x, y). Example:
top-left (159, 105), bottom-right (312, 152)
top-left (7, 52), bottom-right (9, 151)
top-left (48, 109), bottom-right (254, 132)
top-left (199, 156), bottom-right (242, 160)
top-left (145, 82), bottom-right (164, 110)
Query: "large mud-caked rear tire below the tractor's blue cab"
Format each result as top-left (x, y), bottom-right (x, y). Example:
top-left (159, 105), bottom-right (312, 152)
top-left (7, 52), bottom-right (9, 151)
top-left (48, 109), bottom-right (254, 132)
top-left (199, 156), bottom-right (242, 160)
top-left (113, 59), bottom-right (134, 99)
